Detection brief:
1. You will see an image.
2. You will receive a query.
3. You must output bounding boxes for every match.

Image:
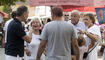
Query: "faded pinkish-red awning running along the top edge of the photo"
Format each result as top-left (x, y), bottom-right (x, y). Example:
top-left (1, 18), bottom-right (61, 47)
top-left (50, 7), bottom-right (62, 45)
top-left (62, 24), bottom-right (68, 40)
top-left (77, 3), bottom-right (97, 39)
top-left (29, 0), bottom-right (105, 6)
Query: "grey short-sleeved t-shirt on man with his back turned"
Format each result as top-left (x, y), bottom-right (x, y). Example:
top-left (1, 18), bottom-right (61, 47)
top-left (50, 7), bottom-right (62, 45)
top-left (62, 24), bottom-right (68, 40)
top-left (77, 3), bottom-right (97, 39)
top-left (41, 20), bottom-right (77, 60)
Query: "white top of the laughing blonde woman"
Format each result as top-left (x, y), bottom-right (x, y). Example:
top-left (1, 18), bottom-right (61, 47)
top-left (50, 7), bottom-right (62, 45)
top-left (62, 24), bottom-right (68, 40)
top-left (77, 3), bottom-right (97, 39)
top-left (26, 33), bottom-right (45, 60)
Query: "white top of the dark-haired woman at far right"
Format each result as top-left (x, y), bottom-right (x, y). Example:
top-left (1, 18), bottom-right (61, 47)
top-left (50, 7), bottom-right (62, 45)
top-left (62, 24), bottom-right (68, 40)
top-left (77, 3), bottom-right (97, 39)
top-left (84, 25), bottom-right (101, 60)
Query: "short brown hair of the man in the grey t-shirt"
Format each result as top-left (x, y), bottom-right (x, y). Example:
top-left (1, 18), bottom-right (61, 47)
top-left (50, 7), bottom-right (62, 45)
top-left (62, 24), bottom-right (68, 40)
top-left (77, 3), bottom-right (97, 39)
top-left (51, 6), bottom-right (63, 17)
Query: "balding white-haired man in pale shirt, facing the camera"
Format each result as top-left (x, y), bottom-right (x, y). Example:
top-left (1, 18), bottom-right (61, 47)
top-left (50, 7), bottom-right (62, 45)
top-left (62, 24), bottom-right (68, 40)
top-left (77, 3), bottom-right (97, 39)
top-left (68, 10), bottom-right (87, 33)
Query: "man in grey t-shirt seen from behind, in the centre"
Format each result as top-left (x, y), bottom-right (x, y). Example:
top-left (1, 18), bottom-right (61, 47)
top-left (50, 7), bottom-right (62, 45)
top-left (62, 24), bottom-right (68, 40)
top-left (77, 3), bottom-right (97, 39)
top-left (36, 6), bottom-right (78, 60)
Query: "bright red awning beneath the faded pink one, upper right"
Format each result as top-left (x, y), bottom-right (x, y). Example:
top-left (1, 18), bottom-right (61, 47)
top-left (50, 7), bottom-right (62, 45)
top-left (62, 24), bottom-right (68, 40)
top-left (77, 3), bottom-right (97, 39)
top-left (62, 5), bottom-right (104, 12)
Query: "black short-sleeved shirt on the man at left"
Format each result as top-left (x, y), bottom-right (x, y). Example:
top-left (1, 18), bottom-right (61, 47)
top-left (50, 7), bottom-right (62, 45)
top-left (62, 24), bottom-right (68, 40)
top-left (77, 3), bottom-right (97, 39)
top-left (5, 18), bottom-right (26, 57)
